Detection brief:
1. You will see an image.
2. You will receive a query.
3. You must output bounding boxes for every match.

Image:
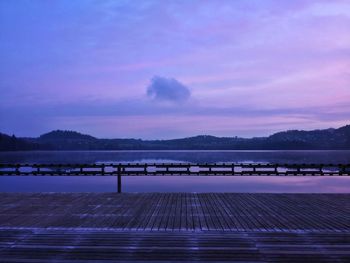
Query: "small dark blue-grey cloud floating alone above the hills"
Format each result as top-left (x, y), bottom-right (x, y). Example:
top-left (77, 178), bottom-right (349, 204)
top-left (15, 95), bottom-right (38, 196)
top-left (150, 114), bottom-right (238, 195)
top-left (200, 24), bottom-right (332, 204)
top-left (147, 76), bottom-right (191, 103)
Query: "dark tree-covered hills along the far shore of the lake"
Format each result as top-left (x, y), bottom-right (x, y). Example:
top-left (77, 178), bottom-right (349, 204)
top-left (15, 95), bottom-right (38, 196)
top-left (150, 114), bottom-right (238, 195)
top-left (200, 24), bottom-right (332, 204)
top-left (0, 125), bottom-right (350, 151)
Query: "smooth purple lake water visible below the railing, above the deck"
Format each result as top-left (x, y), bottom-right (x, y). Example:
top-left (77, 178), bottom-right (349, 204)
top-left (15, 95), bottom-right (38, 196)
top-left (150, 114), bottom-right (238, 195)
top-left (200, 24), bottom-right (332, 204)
top-left (0, 176), bottom-right (350, 193)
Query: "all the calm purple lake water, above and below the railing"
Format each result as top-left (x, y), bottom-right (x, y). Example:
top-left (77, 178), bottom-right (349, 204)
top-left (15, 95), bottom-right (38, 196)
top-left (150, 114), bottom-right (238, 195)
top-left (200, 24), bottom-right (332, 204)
top-left (0, 151), bottom-right (350, 193)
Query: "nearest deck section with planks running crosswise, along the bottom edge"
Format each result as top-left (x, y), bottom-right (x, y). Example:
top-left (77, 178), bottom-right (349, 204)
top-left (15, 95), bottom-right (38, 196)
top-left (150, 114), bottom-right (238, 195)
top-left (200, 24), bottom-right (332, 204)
top-left (0, 229), bottom-right (350, 263)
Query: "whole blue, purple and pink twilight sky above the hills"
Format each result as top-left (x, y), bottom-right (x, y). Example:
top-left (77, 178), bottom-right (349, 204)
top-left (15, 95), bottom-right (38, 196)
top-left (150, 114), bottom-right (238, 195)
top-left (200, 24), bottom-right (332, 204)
top-left (0, 0), bottom-right (350, 139)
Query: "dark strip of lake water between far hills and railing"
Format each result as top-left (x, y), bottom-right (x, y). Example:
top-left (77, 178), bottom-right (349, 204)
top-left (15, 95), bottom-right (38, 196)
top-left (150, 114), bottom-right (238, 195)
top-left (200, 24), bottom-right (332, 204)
top-left (0, 151), bottom-right (350, 164)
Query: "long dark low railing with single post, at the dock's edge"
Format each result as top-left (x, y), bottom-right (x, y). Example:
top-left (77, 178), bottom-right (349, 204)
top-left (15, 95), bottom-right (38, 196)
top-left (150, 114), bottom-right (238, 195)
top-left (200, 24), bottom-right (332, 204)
top-left (0, 163), bottom-right (350, 193)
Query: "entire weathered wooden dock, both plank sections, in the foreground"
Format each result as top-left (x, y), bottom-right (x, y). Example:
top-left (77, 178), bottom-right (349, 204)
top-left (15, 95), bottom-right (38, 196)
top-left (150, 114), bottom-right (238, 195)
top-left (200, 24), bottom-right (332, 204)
top-left (0, 193), bottom-right (350, 262)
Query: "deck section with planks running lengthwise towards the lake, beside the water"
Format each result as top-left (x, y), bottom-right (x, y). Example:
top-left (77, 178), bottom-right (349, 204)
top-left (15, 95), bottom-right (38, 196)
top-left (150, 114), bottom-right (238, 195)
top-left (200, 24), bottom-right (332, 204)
top-left (0, 193), bottom-right (350, 232)
